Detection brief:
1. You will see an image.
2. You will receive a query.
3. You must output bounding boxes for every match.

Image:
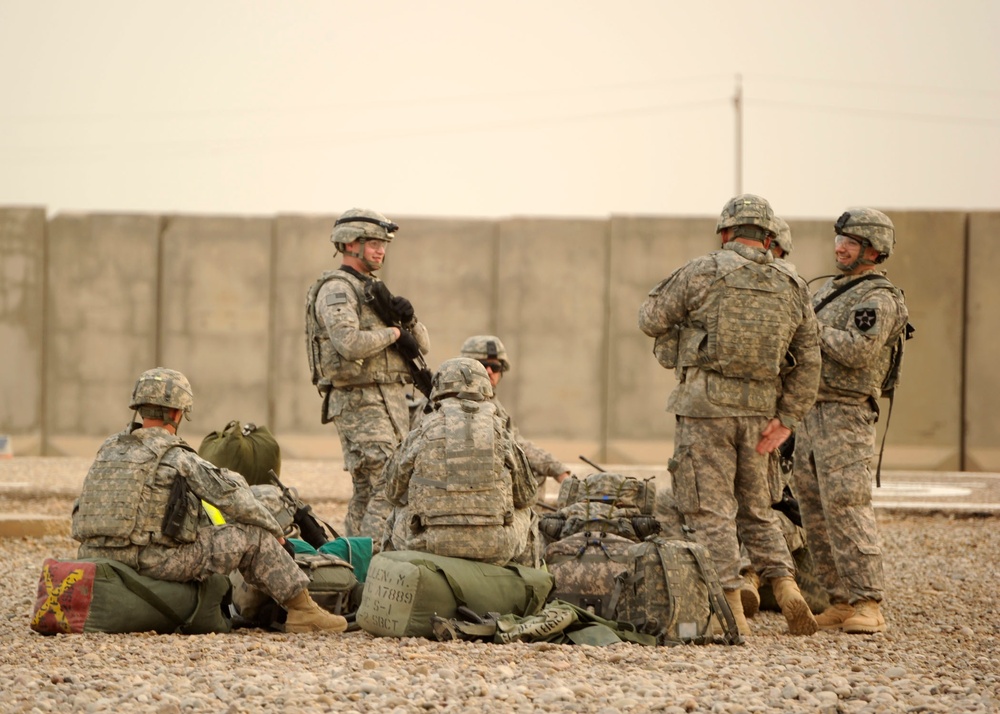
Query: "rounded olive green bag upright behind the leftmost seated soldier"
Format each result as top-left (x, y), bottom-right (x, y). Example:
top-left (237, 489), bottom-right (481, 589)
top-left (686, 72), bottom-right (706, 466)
top-left (198, 420), bottom-right (281, 486)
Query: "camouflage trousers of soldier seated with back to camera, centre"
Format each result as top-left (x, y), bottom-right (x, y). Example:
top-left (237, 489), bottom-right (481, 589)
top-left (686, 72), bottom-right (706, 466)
top-left (386, 506), bottom-right (541, 568)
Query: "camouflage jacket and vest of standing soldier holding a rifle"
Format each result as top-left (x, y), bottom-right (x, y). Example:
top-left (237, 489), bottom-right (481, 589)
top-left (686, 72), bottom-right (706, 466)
top-left (315, 270), bottom-right (430, 387)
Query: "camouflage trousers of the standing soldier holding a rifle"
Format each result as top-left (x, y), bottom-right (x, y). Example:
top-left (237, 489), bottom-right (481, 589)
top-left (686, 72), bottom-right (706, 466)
top-left (327, 384), bottom-right (409, 543)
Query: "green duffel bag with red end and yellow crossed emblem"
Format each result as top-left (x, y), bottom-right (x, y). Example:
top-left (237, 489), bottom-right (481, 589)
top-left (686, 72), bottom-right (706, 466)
top-left (30, 558), bottom-right (232, 635)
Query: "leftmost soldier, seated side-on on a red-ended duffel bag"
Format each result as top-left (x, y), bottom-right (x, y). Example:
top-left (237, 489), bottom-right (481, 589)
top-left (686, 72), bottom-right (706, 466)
top-left (72, 367), bottom-right (347, 632)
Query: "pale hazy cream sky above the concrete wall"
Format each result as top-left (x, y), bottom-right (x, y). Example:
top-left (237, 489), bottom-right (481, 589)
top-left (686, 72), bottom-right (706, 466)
top-left (0, 0), bottom-right (1000, 218)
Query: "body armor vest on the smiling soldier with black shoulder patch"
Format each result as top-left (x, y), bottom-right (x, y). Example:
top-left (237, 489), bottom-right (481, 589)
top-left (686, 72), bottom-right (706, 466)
top-left (813, 278), bottom-right (906, 399)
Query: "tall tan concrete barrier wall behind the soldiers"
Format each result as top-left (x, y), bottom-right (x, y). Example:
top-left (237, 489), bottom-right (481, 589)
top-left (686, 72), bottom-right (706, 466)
top-left (0, 208), bottom-right (1000, 470)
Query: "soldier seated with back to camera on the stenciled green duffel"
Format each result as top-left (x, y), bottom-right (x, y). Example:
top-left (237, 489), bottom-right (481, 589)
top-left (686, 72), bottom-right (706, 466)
top-left (385, 357), bottom-right (540, 567)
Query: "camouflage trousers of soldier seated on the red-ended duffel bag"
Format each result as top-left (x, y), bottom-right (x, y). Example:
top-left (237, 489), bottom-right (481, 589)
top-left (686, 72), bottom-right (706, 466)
top-left (137, 523), bottom-right (309, 603)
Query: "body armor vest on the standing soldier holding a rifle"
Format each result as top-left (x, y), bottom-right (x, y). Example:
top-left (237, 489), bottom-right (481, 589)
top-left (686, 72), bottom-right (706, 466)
top-left (306, 270), bottom-right (412, 393)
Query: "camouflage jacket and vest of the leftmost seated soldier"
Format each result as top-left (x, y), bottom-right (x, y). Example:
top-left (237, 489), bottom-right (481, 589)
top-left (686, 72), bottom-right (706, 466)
top-left (73, 425), bottom-right (283, 563)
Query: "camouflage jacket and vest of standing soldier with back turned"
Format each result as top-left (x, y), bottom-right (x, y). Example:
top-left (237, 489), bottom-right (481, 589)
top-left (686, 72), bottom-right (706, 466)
top-left (639, 241), bottom-right (821, 429)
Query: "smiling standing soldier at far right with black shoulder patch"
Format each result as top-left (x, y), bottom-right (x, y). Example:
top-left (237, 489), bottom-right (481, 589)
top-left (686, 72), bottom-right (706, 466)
top-left (795, 208), bottom-right (908, 633)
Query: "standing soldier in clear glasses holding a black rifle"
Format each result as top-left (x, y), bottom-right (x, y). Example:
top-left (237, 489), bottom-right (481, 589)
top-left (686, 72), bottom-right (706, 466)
top-left (306, 208), bottom-right (430, 548)
